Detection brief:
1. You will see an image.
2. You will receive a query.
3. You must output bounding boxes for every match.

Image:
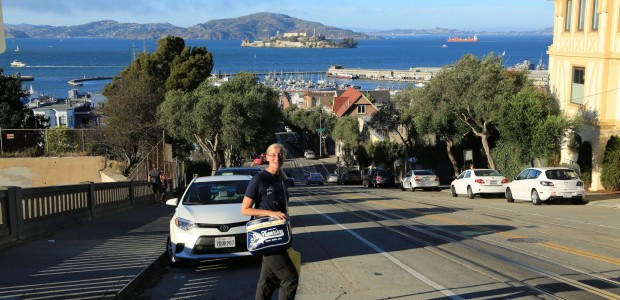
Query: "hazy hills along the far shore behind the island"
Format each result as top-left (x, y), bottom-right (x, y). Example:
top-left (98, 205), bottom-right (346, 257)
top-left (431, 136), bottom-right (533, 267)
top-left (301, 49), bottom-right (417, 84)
top-left (5, 12), bottom-right (553, 40)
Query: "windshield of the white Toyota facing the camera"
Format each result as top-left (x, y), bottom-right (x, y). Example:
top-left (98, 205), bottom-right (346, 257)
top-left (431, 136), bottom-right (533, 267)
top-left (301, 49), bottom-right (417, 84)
top-left (182, 180), bottom-right (250, 205)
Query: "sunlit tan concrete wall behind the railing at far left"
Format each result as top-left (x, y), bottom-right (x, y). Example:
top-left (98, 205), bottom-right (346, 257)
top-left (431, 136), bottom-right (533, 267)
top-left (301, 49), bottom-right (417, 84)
top-left (0, 156), bottom-right (110, 187)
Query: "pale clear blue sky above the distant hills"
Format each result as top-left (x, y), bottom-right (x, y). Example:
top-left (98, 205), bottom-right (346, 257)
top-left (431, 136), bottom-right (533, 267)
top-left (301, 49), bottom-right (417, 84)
top-left (1, 0), bottom-right (554, 30)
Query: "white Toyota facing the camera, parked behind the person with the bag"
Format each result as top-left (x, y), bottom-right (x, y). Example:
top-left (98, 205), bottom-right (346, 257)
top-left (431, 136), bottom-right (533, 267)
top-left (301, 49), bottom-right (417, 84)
top-left (166, 175), bottom-right (251, 266)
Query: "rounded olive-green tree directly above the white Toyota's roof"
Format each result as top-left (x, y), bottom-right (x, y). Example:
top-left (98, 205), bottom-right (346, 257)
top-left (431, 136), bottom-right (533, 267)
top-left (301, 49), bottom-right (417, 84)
top-left (158, 72), bottom-right (282, 174)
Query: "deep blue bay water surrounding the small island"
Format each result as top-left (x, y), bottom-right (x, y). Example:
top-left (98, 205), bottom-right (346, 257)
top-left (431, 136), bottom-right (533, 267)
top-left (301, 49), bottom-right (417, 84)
top-left (0, 35), bottom-right (553, 98)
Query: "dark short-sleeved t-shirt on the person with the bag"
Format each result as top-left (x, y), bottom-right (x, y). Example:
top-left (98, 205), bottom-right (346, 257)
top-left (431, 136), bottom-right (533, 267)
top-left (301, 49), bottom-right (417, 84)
top-left (245, 170), bottom-right (286, 213)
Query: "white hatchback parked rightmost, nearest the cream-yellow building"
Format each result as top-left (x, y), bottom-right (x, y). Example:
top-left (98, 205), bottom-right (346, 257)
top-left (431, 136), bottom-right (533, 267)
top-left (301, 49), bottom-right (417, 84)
top-left (505, 167), bottom-right (586, 205)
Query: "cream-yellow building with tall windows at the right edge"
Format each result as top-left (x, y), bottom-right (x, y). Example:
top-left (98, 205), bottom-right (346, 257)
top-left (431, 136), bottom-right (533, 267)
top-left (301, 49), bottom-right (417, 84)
top-left (547, 0), bottom-right (620, 190)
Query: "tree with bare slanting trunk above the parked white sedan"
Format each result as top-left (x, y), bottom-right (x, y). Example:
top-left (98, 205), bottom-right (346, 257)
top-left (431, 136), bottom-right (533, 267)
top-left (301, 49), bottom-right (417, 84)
top-left (438, 53), bottom-right (528, 168)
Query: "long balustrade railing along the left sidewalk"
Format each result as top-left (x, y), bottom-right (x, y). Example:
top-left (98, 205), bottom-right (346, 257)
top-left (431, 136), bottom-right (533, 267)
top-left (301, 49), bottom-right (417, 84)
top-left (0, 181), bottom-right (154, 247)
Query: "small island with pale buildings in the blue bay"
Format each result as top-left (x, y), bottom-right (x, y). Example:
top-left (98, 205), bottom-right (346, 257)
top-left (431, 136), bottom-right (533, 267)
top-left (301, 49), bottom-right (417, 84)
top-left (241, 32), bottom-right (357, 48)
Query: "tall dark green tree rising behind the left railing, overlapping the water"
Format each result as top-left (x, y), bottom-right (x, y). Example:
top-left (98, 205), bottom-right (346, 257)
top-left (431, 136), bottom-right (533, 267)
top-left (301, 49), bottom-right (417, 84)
top-left (103, 36), bottom-right (213, 171)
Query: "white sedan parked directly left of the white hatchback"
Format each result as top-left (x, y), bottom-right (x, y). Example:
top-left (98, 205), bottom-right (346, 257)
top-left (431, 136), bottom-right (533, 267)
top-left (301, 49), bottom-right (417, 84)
top-left (450, 169), bottom-right (508, 199)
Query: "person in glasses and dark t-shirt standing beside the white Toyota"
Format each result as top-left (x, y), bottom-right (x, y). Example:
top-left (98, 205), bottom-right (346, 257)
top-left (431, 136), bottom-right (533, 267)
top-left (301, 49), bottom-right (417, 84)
top-left (241, 144), bottom-right (299, 299)
